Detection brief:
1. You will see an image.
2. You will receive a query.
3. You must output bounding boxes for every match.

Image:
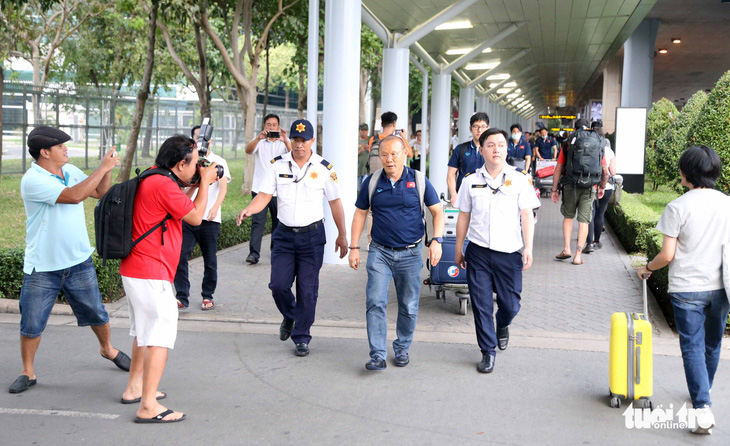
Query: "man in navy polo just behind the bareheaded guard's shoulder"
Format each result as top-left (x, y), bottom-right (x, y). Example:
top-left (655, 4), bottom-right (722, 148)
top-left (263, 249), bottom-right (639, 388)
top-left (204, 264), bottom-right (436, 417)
top-left (446, 112), bottom-right (489, 205)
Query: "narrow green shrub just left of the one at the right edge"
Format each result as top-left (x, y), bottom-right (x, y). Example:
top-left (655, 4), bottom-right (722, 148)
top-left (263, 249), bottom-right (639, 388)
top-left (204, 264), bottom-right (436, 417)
top-left (655, 91), bottom-right (707, 192)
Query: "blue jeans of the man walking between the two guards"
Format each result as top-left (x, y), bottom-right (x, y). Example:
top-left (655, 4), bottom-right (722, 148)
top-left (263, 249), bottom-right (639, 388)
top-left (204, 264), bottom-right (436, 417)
top-left (365, 242), bottom-right (423, 359)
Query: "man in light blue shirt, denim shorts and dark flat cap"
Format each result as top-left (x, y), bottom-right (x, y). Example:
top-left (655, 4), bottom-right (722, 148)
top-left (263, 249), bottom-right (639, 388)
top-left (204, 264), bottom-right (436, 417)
top-left (8, 126), bottom-right (130, 393)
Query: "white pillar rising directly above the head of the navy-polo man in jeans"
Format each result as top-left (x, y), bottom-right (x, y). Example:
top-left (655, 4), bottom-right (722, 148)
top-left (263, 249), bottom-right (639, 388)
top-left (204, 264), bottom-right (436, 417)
top-left (381, 48), bottom-right (411, 131)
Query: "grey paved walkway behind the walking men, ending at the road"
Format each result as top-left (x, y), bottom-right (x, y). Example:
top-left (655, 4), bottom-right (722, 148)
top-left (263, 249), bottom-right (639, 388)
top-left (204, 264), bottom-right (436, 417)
top-left (0, 199), bottom-right (684, 358)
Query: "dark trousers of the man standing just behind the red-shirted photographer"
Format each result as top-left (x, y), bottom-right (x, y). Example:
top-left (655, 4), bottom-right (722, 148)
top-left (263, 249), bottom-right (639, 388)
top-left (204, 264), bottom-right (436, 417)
top-left (175, 220), bottom-right (221, 307)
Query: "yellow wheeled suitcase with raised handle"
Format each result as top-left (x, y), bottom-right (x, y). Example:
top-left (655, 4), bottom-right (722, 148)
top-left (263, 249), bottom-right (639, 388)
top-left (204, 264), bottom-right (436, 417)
top-left (608, 280), bottom-right (654, 409)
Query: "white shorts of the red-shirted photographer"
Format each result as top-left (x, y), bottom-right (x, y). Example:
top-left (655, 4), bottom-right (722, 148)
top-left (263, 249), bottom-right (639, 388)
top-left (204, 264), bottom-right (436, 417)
top-left (122, 276), bottom-right (178, 349)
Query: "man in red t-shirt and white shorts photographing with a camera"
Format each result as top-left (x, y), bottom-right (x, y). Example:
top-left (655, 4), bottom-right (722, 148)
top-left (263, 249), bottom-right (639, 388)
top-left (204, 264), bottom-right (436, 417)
top-left (119, 135), bottom-right (217, 423)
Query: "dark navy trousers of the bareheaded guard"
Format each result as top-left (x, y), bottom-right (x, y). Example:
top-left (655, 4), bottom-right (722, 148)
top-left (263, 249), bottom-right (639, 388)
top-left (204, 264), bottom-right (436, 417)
top-left (464, 243), bottom-right (522, 356)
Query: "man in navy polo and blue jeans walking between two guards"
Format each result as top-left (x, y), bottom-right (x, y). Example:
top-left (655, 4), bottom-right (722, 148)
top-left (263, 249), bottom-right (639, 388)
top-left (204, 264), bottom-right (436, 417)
top-left (349, 136), bottom-right (444, 370)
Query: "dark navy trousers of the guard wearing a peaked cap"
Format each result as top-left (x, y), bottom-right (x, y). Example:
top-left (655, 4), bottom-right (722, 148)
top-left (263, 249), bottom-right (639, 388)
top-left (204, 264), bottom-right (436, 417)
top-left (269, 225), bottom-right (326, 344)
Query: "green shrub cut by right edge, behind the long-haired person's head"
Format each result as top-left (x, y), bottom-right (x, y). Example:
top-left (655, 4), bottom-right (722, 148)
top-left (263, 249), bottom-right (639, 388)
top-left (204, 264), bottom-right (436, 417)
top-left (687, 71), bottom-right (730, 193)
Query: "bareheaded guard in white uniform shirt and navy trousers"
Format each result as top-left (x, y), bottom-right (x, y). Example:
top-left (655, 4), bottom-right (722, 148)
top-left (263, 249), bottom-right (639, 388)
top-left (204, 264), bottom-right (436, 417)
top-left (456, 129), bottom-right (540, 373)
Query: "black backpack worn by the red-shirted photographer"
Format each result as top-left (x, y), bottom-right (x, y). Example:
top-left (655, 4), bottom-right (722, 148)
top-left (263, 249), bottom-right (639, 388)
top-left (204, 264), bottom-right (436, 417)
top-left (94, 168), bottom-right (177, 265)
